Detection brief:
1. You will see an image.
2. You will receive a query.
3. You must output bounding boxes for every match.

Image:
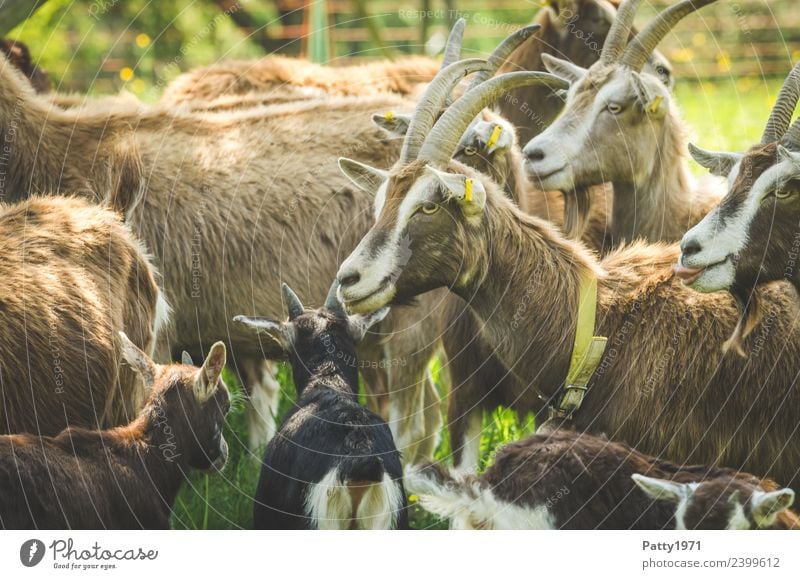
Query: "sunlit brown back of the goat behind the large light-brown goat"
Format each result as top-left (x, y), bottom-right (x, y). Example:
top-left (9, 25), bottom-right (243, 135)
top-left (161, 55), bottom-right (439, 108)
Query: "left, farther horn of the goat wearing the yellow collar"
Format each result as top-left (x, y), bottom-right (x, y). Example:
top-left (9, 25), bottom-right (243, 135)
top-left (400, 58), bottom-right (489, 163)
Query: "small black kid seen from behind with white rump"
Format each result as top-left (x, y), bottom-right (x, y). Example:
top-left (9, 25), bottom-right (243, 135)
top-left (234, 282), bottom-right (408, 529)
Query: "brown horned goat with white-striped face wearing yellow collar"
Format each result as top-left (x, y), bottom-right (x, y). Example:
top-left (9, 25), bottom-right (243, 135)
top-left (337, 65), bottom-right (800, 485)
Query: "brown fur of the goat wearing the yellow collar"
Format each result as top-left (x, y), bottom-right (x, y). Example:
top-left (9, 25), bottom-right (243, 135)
top-left (354, 163), bottom-right (800, 485)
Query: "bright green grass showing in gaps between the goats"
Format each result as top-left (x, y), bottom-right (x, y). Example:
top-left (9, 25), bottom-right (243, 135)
top-left (173, 79), bottom-right (780, 529)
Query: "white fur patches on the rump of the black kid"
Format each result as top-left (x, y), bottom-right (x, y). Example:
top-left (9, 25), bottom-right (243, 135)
top-left (306, 469), bottom-right (403, 530)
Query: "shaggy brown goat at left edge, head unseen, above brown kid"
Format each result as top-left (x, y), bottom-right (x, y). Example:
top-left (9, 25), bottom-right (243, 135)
top-left (0, 171), bottom-right (168, 435)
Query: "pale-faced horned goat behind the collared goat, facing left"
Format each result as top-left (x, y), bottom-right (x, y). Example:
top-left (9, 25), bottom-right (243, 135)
top-left (523, 0), bottom-right (720, 245)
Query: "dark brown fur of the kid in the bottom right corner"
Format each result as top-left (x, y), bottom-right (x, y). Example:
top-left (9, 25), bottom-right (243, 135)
top-left (409, 430), bottom-right (800, 530)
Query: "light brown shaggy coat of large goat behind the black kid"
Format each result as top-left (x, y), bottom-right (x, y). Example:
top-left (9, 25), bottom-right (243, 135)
top-left (0, 54), bottom-right (441, 462)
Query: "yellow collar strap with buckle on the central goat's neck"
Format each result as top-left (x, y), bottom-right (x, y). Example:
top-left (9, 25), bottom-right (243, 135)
top-left (550, 273), bottom-right (608, 419)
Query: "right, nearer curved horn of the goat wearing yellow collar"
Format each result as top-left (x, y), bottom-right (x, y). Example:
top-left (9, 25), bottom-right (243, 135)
top-left (419, 72), bottom-right (569, 167)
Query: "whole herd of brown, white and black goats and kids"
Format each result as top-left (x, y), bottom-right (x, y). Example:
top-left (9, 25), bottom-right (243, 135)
top-left (0, 0), bottom-right (800, 529)
